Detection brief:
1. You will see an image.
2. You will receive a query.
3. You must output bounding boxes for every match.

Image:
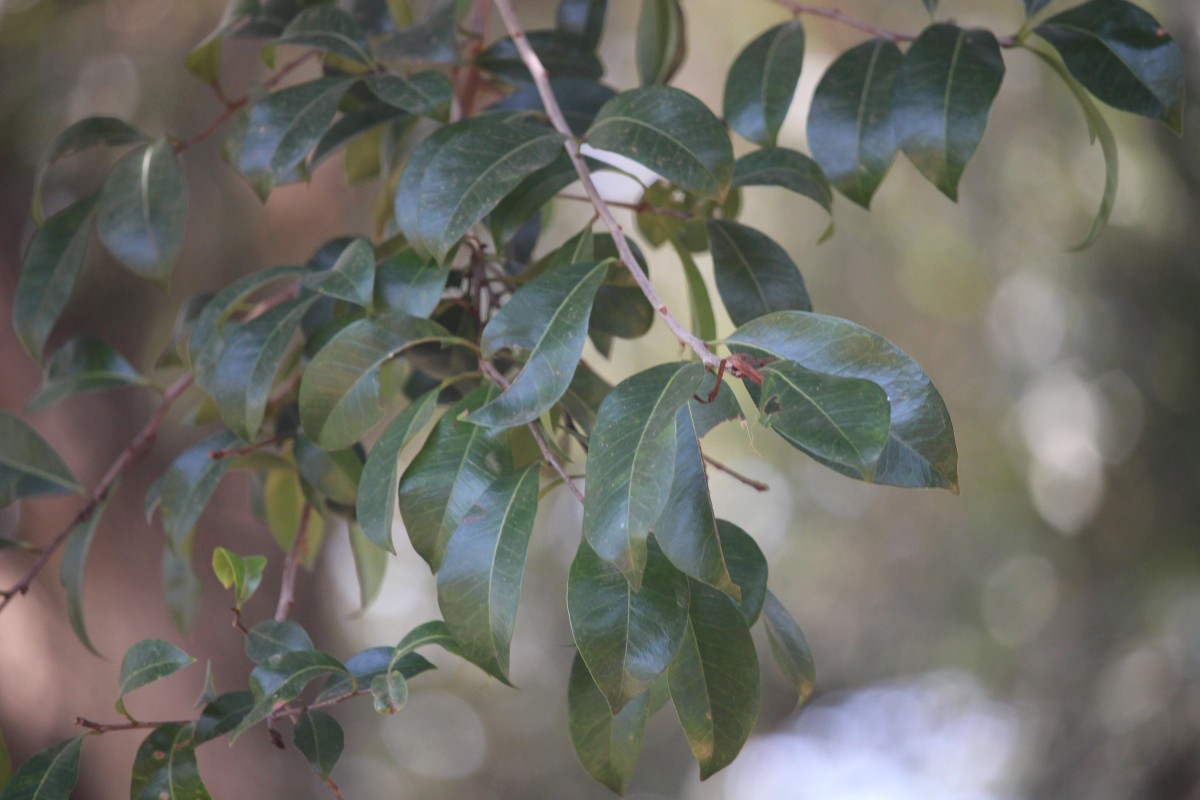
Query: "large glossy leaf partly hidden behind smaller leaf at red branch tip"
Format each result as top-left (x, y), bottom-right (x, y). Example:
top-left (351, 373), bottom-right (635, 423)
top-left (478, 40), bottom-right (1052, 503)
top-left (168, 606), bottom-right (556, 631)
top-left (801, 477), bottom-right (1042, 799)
top-left (727, 312), bottom-right (959, 492)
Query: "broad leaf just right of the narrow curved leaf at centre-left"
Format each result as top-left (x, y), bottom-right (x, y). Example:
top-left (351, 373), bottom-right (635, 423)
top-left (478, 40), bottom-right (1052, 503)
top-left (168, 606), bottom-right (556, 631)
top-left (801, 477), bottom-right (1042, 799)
top-left (398, 387), bottom-right (512, 572)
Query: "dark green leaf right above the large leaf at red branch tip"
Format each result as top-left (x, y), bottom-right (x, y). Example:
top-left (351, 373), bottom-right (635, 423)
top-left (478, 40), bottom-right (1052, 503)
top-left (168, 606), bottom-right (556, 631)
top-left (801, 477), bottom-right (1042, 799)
top-left (708, 219), bottom-right (812, 325)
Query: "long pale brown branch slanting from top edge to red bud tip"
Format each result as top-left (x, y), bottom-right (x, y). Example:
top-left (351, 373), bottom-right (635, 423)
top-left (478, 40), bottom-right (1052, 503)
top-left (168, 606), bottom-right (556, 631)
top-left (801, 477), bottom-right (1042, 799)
top-left (493, 0), bottom-right (721, 371)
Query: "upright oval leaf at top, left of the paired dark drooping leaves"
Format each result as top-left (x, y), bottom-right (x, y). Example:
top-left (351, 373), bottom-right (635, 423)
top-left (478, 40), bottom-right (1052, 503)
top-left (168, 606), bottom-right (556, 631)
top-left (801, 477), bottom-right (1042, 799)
top-left (725, 19), bottom-right (804, 146)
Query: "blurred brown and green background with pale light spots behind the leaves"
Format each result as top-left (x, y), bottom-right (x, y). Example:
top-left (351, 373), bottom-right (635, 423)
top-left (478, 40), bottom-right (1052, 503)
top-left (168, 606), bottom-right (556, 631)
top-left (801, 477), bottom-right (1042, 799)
top-left (0, 0), bottom-right (1200, 800)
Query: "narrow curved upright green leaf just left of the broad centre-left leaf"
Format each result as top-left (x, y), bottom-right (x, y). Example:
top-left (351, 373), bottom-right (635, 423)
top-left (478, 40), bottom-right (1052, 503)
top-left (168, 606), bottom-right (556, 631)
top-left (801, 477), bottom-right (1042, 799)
top-left (356, 390), bottom-right (438, 553)
